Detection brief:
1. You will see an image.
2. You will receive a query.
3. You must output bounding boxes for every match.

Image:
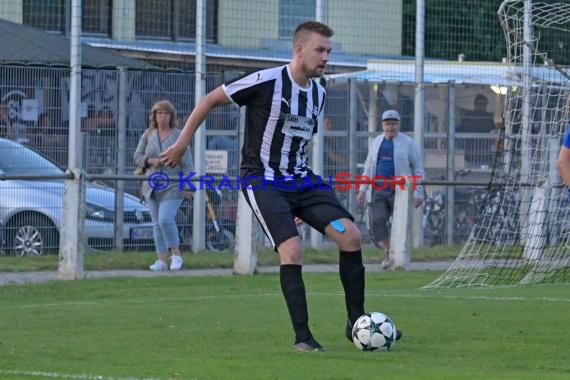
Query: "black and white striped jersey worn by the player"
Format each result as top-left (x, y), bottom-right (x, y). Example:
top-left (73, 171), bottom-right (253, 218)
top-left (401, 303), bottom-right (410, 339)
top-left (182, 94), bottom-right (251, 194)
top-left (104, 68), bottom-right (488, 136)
top-left (223, 65), bottom-right (326, 179)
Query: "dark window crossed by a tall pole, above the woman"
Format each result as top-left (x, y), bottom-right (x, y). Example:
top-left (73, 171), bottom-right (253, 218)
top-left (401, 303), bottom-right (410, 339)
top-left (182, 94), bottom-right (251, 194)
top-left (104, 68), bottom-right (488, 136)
top-left (135, 0), bottom-right (218, 42)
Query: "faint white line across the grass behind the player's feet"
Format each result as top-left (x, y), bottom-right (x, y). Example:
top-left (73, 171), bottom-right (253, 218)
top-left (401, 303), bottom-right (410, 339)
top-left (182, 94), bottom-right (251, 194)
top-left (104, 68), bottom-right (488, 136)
top-left (0, 292), bottom-right (570, 310)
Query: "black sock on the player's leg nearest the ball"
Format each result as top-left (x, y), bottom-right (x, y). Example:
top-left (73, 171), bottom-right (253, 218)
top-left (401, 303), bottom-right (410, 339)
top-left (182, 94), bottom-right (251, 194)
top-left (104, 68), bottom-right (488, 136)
top-left (339, 249), bottom-right (364, 325)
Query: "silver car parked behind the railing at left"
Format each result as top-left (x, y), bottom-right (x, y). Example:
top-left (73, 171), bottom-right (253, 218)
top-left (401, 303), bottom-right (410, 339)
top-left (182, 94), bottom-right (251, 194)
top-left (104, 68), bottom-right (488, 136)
top-left (0, 139), bottom-right (153, 256)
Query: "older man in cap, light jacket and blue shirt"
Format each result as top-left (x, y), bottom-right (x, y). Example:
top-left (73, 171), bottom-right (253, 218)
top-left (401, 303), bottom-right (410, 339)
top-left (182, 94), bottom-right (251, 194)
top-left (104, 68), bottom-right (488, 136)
top-left (356, 110), bottom-right (425, 269)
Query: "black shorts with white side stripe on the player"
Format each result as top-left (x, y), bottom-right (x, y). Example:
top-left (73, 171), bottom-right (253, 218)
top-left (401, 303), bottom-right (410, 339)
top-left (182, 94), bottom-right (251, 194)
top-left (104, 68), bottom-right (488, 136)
top-left (242, 174), bottom-right (354, 250)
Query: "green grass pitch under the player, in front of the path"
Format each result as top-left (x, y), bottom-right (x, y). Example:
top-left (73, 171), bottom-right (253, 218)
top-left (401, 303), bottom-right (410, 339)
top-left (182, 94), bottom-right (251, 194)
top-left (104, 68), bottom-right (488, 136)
top-left (0, 272), bottom-right (570, 380)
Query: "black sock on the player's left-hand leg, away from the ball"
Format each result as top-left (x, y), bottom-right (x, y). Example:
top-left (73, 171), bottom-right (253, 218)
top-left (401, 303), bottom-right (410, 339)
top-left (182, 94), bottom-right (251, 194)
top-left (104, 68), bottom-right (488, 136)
top-left (279, 264), bottom-right (313, 344)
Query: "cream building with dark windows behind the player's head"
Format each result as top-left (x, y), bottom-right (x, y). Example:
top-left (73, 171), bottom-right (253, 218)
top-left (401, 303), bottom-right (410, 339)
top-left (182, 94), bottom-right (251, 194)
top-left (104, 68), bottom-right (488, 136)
top-left (0, 0), bottom-right (402, 73)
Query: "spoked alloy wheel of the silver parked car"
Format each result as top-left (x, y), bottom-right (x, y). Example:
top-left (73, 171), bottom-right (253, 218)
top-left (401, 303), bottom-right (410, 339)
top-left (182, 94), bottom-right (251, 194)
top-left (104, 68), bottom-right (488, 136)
top-left (6, 214), bottom-right (59, 256)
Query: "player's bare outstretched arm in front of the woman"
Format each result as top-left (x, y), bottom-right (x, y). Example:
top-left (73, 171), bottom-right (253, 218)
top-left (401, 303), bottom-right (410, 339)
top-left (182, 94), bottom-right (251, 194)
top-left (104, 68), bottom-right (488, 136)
top-left (160, 86), bottom-right (231, 166)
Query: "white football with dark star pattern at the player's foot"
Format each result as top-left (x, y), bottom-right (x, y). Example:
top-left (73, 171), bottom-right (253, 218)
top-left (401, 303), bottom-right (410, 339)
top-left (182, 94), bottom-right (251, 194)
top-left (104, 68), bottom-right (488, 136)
top-left (352, 312), bottom-right (396, 351)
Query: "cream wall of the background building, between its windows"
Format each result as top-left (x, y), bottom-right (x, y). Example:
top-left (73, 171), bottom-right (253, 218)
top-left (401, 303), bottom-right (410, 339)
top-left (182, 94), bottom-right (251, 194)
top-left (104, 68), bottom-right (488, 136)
top-left (0, 0), bottom-right (402, 55)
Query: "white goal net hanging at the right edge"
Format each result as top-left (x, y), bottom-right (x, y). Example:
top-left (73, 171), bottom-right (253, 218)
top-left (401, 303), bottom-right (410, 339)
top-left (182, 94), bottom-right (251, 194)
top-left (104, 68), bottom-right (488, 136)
top-left (426, 0), bottom-right (570, 288)
